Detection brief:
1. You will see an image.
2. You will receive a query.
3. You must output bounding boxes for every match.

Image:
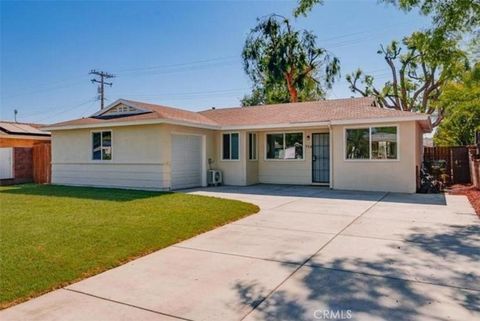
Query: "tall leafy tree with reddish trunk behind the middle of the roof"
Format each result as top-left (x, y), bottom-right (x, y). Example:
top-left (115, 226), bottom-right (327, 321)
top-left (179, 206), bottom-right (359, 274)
top-left (242, 14), bottom-right (340, 106)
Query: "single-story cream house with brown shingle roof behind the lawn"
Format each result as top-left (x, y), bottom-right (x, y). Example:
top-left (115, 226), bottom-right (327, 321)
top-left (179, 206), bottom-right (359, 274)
top-left (46, 98), bottom-right (431, 193)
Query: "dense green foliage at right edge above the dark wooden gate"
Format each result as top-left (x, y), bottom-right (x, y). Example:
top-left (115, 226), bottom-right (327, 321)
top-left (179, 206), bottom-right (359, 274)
top-left (434, 62), bottom-right (480, 146)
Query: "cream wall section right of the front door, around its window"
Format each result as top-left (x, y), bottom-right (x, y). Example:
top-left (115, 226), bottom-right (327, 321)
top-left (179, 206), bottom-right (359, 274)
top-left (332, 121), bottom-right (419, 193)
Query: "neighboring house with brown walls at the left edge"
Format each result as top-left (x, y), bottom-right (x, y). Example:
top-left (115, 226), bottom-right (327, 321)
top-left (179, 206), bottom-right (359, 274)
top-left (0, 121), bottom-right (50, 185)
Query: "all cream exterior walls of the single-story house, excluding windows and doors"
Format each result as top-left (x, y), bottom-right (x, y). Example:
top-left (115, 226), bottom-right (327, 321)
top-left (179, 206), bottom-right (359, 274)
top-left (52, 121), bottom-right (422, 192)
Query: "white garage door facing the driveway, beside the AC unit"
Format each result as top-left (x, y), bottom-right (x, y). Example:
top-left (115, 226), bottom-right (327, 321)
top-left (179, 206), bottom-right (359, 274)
top-left (172, 135), bottom-right (203, 189)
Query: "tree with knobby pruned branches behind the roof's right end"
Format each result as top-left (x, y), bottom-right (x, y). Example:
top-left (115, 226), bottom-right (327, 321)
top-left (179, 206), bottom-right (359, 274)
top-left (346, 31), bottom-right (468, 126)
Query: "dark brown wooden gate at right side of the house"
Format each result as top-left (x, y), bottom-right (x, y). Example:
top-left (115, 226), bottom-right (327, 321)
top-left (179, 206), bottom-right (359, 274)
top-left (423, 146), bottom-right (471, 184)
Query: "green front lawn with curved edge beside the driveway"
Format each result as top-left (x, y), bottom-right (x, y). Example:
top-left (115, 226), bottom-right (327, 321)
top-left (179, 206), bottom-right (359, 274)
top-left (0, 184), bottom-right (258, 307)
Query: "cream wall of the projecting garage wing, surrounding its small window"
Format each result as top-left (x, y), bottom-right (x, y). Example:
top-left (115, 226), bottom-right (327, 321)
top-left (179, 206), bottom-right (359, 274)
top-left (52, 125), bottom-right (214, 190)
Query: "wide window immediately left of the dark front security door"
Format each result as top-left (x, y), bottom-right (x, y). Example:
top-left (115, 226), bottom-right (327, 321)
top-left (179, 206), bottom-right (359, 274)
top-left (266, 133), bottom-right (303, 159)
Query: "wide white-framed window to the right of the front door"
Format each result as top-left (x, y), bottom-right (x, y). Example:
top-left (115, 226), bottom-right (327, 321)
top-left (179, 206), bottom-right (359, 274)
top-left (345, 126), bottom-right (398, 160)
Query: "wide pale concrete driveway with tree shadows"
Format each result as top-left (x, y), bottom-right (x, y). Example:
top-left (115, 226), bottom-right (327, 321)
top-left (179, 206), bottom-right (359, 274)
top-left (0, 185), bottom-right (480, 321)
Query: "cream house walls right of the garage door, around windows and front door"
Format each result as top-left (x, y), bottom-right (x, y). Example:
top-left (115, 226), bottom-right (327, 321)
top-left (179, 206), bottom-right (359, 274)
top-left (224, 121), bottom-right (423, 193)
